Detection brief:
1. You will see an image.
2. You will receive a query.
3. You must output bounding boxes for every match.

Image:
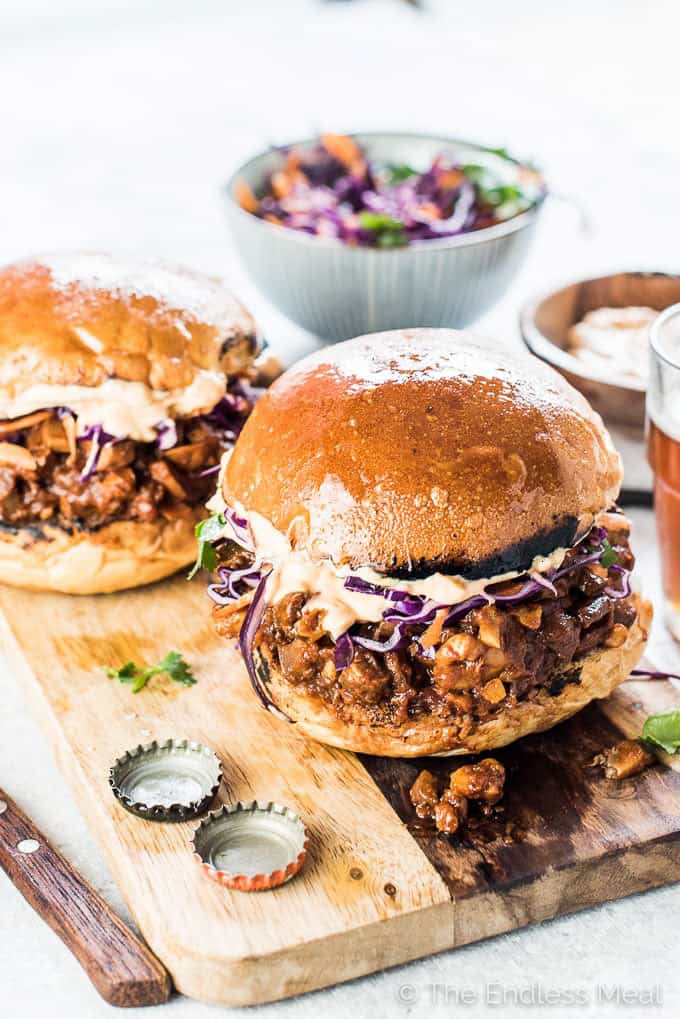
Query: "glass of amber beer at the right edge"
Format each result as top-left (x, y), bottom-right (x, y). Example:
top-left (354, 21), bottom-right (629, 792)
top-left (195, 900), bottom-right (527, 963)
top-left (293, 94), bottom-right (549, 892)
top-left (646, 305), bottom-right (680, 641)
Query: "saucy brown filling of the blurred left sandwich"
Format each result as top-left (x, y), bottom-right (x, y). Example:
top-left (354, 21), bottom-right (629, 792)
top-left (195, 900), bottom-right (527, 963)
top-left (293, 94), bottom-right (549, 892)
top-left (0, 400), bottom-right (251, 534)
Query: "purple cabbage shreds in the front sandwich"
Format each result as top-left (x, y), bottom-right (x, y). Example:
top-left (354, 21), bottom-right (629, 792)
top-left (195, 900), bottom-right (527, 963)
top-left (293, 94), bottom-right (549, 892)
top-left (208, 521), bottom-right (631, 715)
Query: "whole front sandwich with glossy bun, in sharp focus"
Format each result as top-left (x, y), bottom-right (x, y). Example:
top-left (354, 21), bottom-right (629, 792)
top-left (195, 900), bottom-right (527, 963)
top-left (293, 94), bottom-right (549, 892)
top-left (201, 329), bottom-right (650, 756)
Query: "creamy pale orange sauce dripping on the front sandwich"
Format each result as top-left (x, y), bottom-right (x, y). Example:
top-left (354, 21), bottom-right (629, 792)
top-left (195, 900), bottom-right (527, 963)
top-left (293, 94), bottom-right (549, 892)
top-left (208, 476), bottom-right (569, 639)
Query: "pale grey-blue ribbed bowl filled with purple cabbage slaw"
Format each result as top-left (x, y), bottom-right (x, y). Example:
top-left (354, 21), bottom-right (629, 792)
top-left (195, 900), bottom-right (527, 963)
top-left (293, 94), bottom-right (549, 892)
top-left (225, 132), bottom-right (546, 341)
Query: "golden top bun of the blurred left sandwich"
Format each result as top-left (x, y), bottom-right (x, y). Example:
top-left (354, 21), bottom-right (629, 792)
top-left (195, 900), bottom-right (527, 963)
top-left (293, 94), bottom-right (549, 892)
top-left (0, 253), bottom-right (256, 394)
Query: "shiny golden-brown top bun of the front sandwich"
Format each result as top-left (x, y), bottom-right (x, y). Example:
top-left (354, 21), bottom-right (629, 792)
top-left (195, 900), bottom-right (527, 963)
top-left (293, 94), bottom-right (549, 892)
top-left (223, 329), bottom-right (621, 577)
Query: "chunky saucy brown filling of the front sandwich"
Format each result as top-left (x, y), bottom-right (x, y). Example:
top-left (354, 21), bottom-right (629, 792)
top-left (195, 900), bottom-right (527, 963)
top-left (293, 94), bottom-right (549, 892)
top-left (213, 514), bottom-right (636, 738)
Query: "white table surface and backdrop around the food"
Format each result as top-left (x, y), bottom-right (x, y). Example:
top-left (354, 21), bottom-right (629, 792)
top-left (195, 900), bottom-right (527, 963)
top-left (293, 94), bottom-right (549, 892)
top-left (0, 0), bottom-right (680, 1019)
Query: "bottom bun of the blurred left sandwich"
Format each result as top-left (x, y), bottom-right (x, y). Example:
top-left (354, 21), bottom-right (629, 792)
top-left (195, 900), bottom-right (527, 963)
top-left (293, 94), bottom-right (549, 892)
top-left (0, 507), bottom-right (205, 594)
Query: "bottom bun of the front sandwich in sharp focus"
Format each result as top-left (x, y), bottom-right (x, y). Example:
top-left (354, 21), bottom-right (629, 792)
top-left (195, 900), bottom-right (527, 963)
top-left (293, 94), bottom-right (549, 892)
top-left (257, 596), bottom-right (651, 757)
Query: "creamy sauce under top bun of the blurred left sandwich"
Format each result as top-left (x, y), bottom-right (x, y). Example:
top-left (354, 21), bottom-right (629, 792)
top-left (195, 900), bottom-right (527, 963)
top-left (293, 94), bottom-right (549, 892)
top-left (0, 371), bottom-right (226, 442)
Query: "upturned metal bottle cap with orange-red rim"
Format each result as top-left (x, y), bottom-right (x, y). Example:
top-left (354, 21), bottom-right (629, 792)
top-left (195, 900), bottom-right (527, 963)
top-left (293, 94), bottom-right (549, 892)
top-left (192, 801), bottom-right (309, 892)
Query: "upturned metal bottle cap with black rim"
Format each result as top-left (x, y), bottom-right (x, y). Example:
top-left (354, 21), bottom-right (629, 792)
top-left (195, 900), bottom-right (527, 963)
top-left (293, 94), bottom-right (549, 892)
top-left (109, 740), bottom-right (222, 821)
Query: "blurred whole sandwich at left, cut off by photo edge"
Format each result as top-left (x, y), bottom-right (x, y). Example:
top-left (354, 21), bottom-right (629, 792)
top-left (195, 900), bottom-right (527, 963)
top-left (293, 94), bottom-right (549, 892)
top-left (0, 254), bottom-right (257, 594)
